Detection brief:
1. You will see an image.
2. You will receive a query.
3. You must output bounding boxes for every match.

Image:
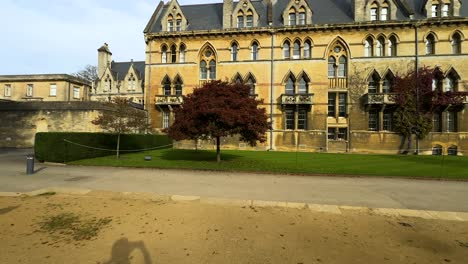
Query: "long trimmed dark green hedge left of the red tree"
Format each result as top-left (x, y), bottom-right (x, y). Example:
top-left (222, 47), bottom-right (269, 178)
top-left (34, 132), bottom-right (172, 163)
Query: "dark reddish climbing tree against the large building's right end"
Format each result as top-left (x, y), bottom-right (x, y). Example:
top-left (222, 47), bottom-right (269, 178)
top-left (393, 67), bottom-right (467, 153)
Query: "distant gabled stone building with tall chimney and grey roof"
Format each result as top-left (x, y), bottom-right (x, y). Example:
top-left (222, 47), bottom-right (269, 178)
top-left (91, 43), bottom-right (145, 105)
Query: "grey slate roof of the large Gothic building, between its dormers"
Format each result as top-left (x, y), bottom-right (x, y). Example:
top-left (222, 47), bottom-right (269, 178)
top-left (145, 0), bottom-right (468, 33)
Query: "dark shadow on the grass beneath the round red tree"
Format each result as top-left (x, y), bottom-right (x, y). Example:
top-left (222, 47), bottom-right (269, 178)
top-left (161, 149), bottom-right (242, 162)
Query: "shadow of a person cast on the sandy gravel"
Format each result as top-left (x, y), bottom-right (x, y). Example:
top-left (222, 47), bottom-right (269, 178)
top-left (104, 237), bottom-right (154, 264)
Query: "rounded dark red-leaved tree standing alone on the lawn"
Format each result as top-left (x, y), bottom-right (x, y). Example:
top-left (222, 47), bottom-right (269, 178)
top-left (167, 81), bottom-right (270, 162)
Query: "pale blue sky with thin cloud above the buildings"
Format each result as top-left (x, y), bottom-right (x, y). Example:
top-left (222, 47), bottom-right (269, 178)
top-left (0, 0), bottom-right (223, 75)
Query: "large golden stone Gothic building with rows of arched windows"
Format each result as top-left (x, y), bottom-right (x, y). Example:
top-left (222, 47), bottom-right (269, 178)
top-left (144, 0), bottom-right (468, 154)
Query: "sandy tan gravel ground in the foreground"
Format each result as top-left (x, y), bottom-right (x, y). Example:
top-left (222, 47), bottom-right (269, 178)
top-left (0, 192), bottom-right (468, 264)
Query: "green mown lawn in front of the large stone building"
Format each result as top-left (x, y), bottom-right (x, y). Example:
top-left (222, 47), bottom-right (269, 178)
top-left (70, 149), bottom-right (468, 179)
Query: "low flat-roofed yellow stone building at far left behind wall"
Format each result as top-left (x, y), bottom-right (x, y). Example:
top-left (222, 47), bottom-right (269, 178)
top-left (0, 74), bottom-right (91, 101)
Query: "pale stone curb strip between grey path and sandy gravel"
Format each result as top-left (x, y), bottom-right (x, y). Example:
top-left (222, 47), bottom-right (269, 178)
top-left (0, 187), bottom-right (468, 222)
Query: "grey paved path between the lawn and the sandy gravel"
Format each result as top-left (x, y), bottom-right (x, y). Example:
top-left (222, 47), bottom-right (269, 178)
top-left (0, 150), bottom-right (468, 212)
